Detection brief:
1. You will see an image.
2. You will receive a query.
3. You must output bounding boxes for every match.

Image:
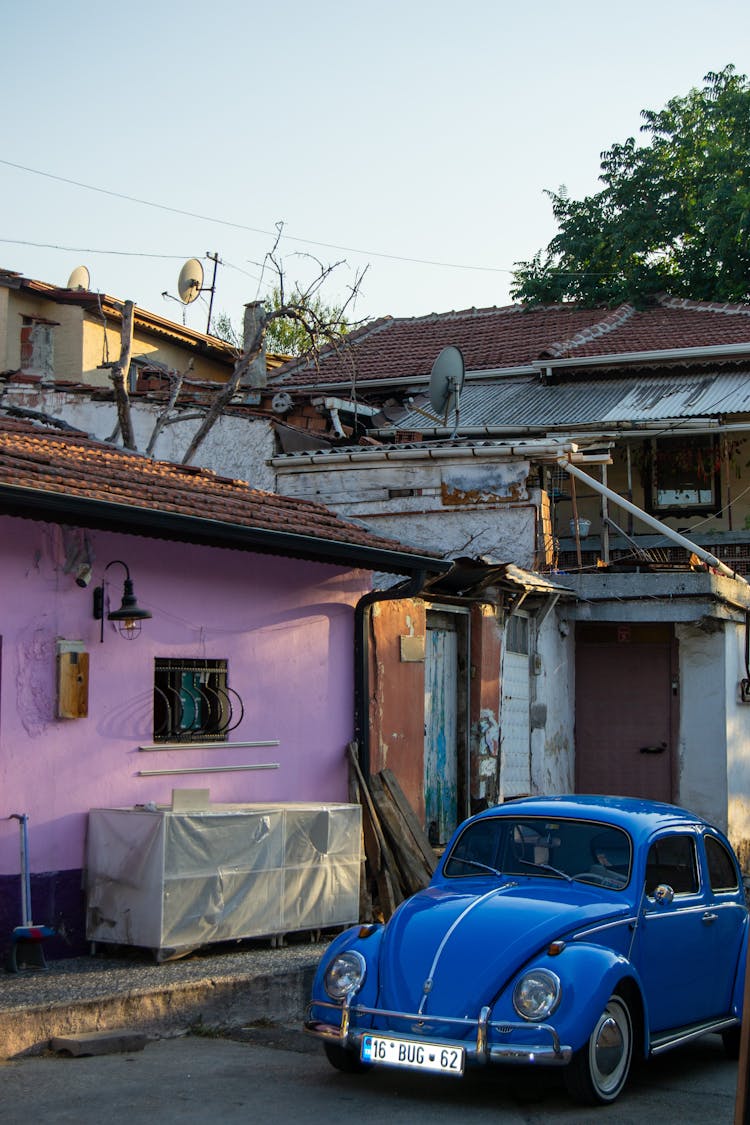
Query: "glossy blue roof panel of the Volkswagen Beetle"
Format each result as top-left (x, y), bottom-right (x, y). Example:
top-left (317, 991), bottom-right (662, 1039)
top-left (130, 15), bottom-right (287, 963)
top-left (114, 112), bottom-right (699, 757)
top-left (479, 793), bottom-right (708, 835)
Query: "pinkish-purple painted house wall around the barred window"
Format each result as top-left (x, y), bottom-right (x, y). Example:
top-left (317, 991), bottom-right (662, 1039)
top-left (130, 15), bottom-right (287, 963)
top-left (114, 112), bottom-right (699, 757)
top-left (0, 516), bottom-right (370, 874)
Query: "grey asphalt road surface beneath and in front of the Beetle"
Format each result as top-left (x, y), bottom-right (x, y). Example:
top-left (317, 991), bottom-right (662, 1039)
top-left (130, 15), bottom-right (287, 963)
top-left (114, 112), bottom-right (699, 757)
top-left (0, 1028), bottom-right (737, 1125)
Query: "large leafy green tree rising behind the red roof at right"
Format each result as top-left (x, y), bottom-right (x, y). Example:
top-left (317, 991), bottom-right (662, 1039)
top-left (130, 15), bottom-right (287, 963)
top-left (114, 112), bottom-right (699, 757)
top-left (510, 65), bottom-right (750, 304)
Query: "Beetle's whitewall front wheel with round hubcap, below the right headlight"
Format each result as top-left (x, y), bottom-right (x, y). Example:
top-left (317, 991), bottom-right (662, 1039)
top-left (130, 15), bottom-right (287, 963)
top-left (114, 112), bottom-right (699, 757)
top-left (564, 993), bottom-right (633, 1106)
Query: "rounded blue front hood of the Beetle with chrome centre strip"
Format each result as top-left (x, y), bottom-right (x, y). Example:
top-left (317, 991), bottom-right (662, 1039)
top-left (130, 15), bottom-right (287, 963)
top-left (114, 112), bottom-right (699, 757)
top-left (379, 879), bottom-right (630, 1017)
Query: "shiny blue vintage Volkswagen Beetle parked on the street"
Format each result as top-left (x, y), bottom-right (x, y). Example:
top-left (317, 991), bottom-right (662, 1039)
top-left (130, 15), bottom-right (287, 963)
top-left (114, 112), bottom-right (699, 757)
top-left (305, 797), bottom-right (748, 1105)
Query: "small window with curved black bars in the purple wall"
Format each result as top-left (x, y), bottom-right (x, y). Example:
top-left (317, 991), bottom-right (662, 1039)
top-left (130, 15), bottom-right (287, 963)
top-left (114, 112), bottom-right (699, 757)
top-left (154, 657), bottom-right (243, 743)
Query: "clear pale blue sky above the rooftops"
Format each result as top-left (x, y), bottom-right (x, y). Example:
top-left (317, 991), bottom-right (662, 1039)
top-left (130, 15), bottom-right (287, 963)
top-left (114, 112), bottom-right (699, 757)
top-left (0, 0), bottom-right (750, 332)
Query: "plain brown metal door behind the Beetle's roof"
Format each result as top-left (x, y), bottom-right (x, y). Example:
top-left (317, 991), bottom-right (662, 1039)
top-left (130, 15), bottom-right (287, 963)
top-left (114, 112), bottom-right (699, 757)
top-left (576, 623), bottom-right (677, 801)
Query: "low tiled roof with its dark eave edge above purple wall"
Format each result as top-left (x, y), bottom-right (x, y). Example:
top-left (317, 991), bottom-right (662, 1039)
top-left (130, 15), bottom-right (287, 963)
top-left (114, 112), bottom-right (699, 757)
top-left (0, 419), bottom-right (442, 573)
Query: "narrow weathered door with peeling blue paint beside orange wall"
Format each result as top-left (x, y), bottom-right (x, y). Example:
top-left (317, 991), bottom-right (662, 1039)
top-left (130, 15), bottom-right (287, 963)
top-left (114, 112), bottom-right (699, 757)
top-left (424, 615), bottom-right (459, 844)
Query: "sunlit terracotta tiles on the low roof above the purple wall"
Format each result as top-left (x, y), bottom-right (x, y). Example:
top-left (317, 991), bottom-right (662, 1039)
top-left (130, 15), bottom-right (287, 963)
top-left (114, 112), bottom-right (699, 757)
top-left (0, 419), bottom-right (436, 567)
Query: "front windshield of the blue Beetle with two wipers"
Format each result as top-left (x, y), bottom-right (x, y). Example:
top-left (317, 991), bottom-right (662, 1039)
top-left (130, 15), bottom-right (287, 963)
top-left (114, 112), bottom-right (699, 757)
top-left (443, 816), bottom-right (632, 889)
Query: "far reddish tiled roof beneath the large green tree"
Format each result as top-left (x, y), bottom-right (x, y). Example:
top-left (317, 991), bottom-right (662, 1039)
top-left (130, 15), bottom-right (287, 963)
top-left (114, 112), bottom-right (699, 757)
top-left (272, 296), bottom-right (750, 387)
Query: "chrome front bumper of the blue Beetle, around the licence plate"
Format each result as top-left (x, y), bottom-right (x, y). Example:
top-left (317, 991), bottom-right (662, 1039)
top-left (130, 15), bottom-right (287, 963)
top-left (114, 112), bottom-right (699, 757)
top-left (305, 1000), bottom-right (572, 1067)
